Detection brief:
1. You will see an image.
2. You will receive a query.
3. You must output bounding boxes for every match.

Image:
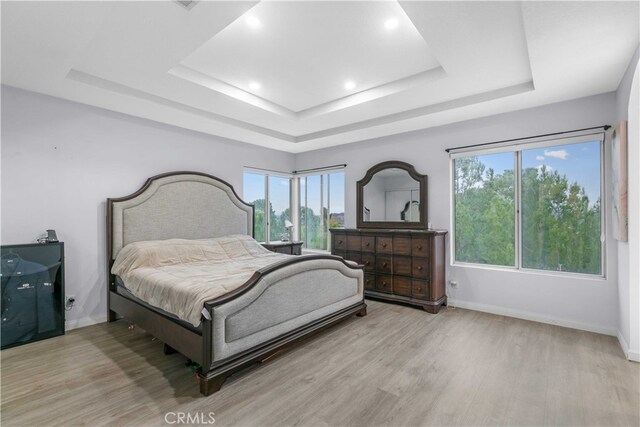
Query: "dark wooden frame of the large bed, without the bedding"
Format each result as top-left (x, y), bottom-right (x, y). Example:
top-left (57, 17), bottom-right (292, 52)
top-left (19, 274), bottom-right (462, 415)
top-left (107, 172), bottom-right (367, 395)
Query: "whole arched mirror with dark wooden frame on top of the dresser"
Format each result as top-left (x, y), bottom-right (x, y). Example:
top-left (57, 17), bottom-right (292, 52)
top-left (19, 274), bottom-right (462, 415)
top-left (357, 161), bottom-right (427, 229)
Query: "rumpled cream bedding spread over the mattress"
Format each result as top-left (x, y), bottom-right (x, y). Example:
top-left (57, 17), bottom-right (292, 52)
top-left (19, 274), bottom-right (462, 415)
top-left (111, 235), bottom-right (291, 326)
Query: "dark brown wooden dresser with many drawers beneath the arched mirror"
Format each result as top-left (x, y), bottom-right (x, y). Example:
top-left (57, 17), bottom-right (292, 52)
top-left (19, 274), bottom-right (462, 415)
top-left (330, 228), bottom-right (447, 313)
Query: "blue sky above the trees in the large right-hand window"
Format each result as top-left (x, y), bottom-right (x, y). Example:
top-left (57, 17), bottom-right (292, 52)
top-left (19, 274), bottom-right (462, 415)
top-left (479, 141), bottom-right (600, 204)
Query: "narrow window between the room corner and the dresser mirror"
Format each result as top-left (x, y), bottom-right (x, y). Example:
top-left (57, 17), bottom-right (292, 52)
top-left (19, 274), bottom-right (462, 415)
top-left (298, 172), bottom-right (344, 250)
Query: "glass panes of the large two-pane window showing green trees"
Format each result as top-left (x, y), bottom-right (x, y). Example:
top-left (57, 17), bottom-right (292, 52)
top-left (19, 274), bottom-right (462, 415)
top-left (452, 136), bottom-right (604, 275)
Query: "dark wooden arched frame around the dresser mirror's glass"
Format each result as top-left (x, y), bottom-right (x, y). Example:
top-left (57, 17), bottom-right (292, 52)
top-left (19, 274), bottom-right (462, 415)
top-left (356, 160), bottom-right (428, 230)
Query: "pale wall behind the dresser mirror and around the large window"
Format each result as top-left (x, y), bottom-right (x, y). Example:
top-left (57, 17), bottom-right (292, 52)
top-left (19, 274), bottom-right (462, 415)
top-left (296, 93), bottom-right (618, 335)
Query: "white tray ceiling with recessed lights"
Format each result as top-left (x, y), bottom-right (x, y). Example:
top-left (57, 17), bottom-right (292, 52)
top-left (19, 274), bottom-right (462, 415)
top-left (1, 1), bottom-right (640, 153)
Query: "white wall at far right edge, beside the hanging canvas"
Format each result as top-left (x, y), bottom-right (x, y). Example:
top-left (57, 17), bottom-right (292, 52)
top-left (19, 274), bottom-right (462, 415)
top-left (616, 47), bottom-right (640, 362)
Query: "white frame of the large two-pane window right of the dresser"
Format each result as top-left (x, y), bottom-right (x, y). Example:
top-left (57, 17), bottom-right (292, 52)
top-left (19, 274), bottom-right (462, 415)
top-left (449, 132), bottom-right (608, 280)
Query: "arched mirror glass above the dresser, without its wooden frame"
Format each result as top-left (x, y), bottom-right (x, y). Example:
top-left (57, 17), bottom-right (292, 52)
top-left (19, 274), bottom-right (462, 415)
top-left (362, 168), bottom-right (420, 222)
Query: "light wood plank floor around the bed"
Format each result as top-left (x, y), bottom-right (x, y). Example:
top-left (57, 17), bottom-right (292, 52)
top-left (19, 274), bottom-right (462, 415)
top-left (1, 301), bottom-right (640, 426)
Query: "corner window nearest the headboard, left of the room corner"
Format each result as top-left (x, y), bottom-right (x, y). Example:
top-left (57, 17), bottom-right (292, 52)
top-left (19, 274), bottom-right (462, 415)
top-left (243, 172), bottom-right (291, 242)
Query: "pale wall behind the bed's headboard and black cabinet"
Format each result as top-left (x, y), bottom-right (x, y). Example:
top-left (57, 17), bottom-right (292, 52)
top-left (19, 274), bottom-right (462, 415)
top-left (0, 86), bottom-right (294, 327)
